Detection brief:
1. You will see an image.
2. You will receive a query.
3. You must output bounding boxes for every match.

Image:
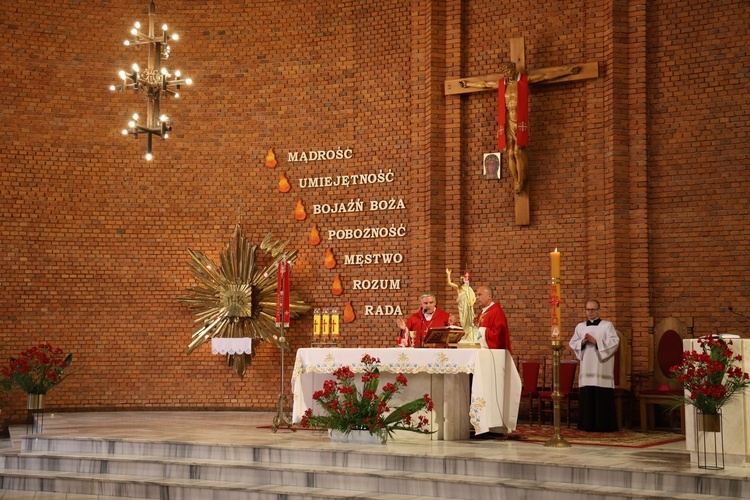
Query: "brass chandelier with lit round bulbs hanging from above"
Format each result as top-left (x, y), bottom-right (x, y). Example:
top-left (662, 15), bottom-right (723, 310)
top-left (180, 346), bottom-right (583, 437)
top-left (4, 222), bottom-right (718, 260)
top-left (109, 0), bottom-right (193, 161)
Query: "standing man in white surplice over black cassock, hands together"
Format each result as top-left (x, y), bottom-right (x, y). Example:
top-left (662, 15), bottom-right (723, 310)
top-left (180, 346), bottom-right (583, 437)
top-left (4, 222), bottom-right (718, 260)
top-left (570, 300), bottom-right (620, 432)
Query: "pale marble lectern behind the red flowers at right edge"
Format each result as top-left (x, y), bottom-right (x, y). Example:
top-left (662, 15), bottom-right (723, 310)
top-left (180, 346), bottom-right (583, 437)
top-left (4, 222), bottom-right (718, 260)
top-left (682, 336), bottom-right (750, 466)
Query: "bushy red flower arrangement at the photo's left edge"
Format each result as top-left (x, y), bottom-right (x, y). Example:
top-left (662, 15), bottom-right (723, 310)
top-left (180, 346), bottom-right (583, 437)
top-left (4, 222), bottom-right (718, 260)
top-left (0, 344), bottom-right (73, 394)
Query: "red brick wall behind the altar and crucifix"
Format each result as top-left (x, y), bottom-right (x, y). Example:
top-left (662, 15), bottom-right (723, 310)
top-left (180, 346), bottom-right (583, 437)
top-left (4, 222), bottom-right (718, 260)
top-left (0, 0), bottom-right (750, 418)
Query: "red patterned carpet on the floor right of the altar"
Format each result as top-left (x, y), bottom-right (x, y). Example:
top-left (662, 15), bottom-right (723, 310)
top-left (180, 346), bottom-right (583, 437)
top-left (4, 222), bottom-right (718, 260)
top-left (482, 424), bottom-right (685, 448)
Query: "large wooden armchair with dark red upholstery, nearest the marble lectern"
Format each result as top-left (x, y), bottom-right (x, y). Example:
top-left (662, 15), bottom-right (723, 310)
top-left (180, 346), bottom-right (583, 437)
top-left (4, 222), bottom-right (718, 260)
top-left (638, 318), bottom-right (693, 434)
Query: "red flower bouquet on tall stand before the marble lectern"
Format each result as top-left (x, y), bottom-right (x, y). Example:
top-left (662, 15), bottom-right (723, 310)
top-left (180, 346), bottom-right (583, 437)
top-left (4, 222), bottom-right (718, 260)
top-left (671, 337), bottom-right (750, 414)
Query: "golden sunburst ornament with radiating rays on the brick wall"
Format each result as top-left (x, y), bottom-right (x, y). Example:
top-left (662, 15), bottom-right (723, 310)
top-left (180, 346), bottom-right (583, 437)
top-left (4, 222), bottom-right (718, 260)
top-left (177, 223), bottom-right (310, 377)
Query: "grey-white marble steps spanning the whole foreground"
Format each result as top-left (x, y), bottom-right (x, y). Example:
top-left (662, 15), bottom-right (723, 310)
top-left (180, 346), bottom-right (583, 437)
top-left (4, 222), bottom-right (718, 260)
top-left (0, 434), bottom-right (750, 500)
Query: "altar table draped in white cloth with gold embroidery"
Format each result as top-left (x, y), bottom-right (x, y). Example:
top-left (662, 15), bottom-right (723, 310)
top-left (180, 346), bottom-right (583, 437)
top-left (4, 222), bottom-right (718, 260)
top-left (292, 348), bottom-right (521, 441)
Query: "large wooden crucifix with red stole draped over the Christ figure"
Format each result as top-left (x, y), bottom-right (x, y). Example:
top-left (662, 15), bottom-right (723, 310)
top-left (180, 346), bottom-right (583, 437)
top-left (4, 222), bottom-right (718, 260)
top-left (445, 37), bottom-right (599, 226)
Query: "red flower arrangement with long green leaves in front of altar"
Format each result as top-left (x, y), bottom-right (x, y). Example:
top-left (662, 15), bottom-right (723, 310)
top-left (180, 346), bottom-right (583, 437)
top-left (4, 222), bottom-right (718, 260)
top-left (302, 354), bottom-right (433, 443)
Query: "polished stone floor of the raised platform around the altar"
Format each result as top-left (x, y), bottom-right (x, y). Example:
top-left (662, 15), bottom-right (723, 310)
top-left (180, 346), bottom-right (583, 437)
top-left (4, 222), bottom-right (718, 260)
top-left (0, 412), bottom-right (750, 500)
